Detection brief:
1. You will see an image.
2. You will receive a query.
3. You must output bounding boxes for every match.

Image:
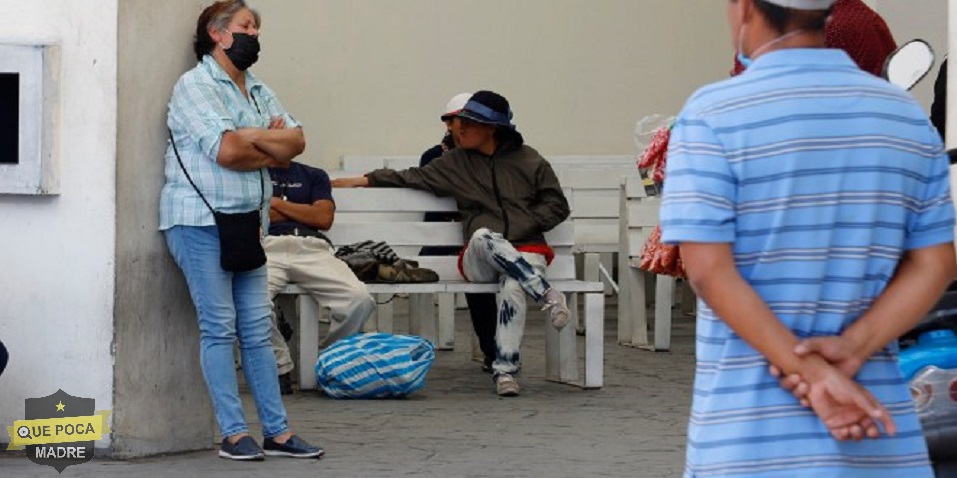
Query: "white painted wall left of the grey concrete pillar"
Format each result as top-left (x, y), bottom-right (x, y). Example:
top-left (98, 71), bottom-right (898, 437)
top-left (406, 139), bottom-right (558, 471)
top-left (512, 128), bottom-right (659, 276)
top-left (0, 0), bottom-right (117, 447)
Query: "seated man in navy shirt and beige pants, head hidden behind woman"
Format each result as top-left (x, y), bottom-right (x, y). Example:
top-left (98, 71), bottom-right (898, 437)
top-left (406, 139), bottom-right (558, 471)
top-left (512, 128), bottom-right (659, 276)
top-left (263, 162), bottom-right (375, 395)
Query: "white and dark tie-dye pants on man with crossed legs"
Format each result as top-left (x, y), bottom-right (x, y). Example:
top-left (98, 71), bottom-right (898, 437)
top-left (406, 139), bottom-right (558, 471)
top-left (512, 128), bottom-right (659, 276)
top-left (462, 228), bottom-right (550, 375)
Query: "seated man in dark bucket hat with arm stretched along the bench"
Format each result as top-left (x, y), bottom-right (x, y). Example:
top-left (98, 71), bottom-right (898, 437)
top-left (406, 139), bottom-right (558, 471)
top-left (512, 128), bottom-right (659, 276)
top-left (333, 90), bottom-right (570, 396)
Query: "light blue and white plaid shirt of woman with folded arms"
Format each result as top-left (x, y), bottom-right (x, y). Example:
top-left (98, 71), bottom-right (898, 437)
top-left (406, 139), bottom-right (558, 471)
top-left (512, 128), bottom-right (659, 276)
top-left (160, 55), bottom-right (300, 230)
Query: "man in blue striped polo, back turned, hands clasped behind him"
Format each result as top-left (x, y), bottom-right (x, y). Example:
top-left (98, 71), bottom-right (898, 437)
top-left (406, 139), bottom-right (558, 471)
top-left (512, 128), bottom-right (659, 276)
top-left (661, 0), bottom-right (957, 477)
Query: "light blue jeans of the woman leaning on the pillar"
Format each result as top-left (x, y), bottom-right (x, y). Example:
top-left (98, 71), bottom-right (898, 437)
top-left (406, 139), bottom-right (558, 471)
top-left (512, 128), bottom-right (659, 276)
top-left (165, 226), bottom-right (289, 438)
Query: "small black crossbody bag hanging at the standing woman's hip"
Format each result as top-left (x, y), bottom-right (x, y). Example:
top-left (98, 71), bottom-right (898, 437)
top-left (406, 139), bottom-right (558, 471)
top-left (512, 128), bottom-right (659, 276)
top-left (169, 131), bottom-right (266, 272)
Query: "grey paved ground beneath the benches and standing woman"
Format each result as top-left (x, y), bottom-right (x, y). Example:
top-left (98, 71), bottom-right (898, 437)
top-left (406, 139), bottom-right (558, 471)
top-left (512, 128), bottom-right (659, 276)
top-left (0, 298), bottom-right (694, 478)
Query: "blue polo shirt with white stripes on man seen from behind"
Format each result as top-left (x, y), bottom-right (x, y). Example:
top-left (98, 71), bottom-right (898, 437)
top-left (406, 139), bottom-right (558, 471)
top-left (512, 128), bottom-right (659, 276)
top-left (661, 49), bottom-right (954, 477)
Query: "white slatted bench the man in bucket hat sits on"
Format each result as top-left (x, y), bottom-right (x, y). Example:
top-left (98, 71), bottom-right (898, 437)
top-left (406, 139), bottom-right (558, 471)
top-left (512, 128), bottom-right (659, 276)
top-left (282, 188), bottom-right (604, 390)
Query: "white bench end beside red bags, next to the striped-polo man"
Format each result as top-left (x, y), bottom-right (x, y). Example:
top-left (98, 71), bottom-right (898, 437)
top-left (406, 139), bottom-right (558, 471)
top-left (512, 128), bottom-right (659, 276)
top-left (618, 177), bottom-right (692, 350)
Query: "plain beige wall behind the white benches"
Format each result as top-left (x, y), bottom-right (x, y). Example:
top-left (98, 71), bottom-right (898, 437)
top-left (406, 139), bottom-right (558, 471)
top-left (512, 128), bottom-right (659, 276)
top-left (251, 0), bottom-right (733, 167)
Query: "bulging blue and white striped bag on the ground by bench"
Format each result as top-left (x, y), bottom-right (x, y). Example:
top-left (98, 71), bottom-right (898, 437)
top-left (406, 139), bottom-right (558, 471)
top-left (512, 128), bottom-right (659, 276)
top-left (316, 334), bottom-right (435, 398)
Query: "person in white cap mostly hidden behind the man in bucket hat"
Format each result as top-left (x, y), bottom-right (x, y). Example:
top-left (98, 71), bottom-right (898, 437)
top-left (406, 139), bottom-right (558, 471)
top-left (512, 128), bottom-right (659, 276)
top-left (419, 93), bottom-right (498, 372)
